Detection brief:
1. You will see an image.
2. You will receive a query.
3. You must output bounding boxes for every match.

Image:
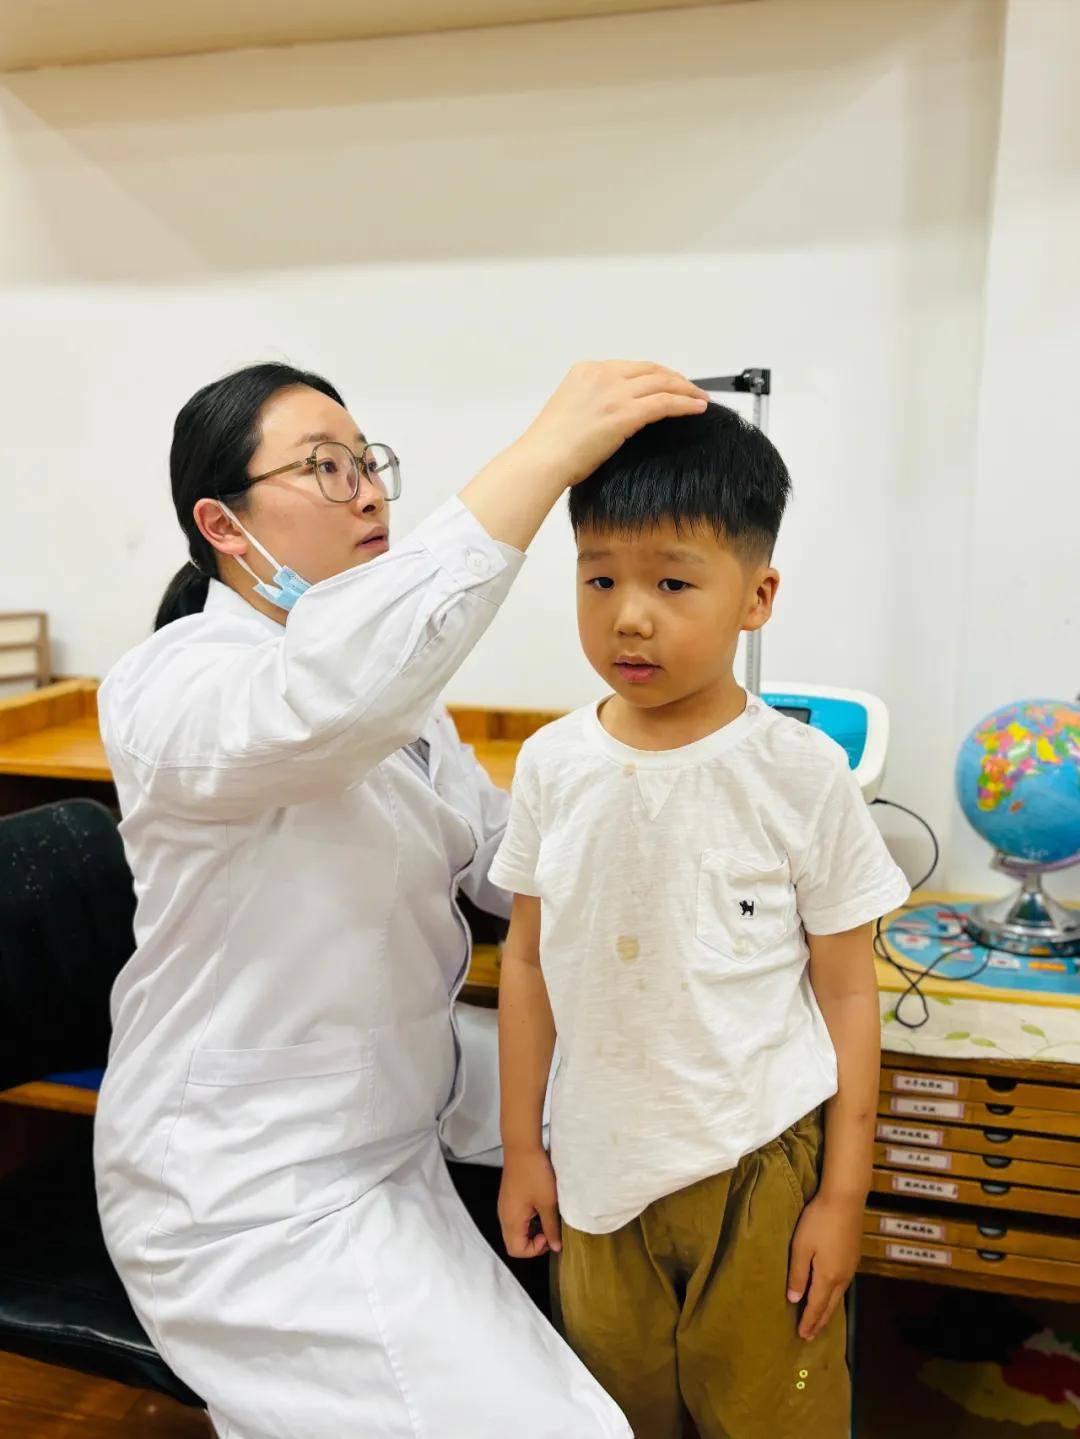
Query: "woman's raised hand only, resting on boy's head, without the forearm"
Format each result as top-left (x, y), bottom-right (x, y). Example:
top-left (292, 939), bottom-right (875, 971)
top-left (518, 360), bottom-right (709, 485)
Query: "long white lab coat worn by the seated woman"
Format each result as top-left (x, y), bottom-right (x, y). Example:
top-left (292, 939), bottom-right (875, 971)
top-left (95, 501), bottom-right (630, 1439)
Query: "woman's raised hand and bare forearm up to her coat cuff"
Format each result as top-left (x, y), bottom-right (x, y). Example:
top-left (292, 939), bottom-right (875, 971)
top-left (460, 360), bottom-right (709, 550)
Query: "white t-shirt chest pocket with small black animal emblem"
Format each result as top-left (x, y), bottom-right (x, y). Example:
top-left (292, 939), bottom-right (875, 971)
top-left (697, 849), bottom-right (797, 964)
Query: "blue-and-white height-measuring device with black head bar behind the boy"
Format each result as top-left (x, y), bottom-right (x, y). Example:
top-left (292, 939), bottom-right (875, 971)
top-left (693, 370), bottom-right (889, 804)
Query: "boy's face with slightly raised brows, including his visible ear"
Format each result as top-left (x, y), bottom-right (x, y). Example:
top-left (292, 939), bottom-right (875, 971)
top-left (577, 521), bottom-right (779, 709)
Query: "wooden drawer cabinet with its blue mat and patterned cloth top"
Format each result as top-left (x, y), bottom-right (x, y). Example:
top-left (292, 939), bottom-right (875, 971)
top-left (864, 894), bottom-right (1080, 1301)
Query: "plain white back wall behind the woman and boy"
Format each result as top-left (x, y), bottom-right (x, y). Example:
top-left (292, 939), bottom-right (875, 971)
top-left (0, 0), bottom-right (1076, 884)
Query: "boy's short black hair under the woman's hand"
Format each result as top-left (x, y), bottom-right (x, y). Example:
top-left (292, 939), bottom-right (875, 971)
top-left (569, 404), bottom-right (791, 563)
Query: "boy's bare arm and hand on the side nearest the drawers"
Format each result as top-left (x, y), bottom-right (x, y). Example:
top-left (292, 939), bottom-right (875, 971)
top-left (788, 924), bottom-right (882, 1340)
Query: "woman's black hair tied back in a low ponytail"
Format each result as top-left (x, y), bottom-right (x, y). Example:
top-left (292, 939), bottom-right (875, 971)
top-left (154, 363), bottom-right (345, 630)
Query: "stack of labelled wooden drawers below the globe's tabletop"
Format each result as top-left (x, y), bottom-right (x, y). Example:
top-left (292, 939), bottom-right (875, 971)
top-left (861, 1053), bottom-right (1080, 1301)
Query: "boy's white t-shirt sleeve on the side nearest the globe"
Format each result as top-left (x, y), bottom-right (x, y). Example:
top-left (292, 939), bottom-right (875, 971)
top-left (795, 761), bottom-right (912, 934)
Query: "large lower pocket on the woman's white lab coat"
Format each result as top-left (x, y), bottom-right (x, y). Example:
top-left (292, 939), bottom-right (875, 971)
top-left (157, 1035), bottom-right (374, 1233)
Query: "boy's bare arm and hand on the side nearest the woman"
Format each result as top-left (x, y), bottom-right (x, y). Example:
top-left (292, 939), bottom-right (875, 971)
top-left (499, 895), bottom-right (562, 1259)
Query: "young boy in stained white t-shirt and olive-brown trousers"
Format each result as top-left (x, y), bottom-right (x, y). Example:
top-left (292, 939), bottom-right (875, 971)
top-left (492, 406), bottom-right (909, 1439)
